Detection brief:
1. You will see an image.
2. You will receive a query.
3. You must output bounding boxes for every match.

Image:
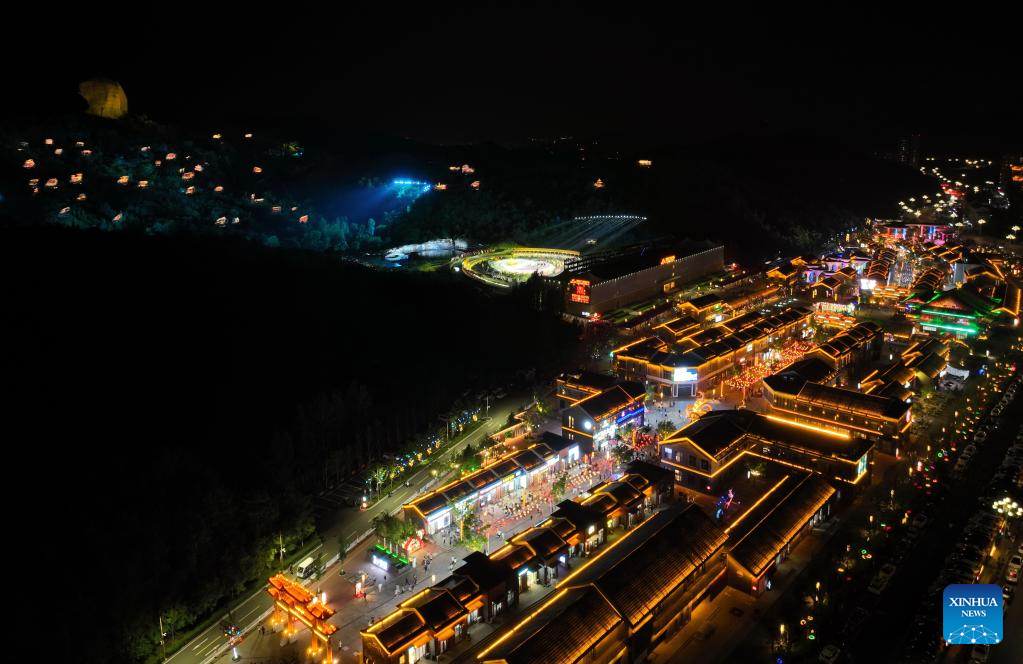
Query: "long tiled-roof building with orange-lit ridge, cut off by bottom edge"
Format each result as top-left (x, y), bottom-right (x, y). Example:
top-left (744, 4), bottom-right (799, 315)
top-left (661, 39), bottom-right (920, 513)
top-left (477, 505), bottom-right (726, 664)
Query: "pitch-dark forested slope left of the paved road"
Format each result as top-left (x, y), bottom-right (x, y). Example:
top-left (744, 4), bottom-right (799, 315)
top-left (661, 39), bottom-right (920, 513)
top-left (7, 226), bottom-right (577, 662)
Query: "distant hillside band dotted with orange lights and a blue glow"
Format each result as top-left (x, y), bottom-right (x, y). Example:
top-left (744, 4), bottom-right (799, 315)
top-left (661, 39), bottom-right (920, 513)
top-left (6, 116), bottom-right (933, 260)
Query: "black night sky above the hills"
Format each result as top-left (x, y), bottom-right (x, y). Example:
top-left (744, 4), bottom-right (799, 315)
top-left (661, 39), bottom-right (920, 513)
top-left (5, 4), bottom-right (1021, 148)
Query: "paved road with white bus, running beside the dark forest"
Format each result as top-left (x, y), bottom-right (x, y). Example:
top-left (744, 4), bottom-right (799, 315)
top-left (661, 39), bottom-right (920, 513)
top-left (167, 390), bottom-right (532, 664)
